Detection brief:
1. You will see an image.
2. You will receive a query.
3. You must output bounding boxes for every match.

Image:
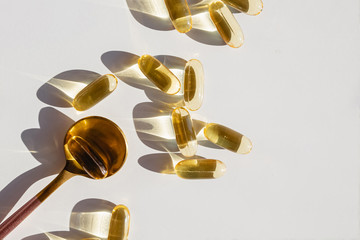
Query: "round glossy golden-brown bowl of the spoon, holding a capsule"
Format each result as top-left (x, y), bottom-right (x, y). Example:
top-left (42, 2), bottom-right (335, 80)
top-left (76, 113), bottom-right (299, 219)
top-left (64, 116), bottom-right (128, 179)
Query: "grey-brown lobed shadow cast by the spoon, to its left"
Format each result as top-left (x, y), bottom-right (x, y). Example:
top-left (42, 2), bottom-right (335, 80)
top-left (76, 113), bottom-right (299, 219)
top-left (0, 107), bottom-right (74, 222)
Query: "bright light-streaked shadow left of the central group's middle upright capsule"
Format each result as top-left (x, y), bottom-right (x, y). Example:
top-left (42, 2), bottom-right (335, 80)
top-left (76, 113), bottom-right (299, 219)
top-left (133, 102), bottom-right (179, 152)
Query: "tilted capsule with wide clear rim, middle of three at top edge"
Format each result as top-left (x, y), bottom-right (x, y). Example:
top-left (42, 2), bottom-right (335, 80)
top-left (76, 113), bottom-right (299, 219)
top-left (209, 1), bottom-right (244, 48)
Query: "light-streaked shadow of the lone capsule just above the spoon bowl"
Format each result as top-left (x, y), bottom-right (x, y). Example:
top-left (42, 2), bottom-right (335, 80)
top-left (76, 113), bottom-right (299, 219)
top-left (36, 69), bottom-right (101, 107)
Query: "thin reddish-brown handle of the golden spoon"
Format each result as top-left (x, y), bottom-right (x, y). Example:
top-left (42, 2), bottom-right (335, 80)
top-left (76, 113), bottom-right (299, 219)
top-left (0, 170), bottom-right (75, 239)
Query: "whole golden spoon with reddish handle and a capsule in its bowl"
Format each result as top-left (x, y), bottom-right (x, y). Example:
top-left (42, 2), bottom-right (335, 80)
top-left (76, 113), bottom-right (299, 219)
top-left (0, 116), bottom-right (128, 239)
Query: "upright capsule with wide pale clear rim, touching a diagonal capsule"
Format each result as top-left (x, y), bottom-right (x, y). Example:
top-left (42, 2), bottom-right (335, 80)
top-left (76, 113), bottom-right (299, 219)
top-left (184, 59), bottom-right (204, 111)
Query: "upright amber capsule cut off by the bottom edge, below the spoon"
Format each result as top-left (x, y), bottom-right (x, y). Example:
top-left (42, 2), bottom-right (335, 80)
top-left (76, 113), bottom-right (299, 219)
top-left (108, 205), bottom-right (130, 240)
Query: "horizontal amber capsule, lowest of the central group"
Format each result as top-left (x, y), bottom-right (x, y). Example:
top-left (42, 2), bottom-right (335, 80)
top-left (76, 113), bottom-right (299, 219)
top-left (175, 159), bottom-right (226, 179)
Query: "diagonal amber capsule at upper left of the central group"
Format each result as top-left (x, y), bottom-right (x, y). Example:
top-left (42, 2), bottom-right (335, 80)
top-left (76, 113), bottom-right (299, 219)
top-left (138, 55), bottom-right (181, 95)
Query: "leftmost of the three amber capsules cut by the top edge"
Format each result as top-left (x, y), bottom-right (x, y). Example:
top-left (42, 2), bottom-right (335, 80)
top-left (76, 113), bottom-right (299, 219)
top-left (165, 0), bottom-right (192, 33)
